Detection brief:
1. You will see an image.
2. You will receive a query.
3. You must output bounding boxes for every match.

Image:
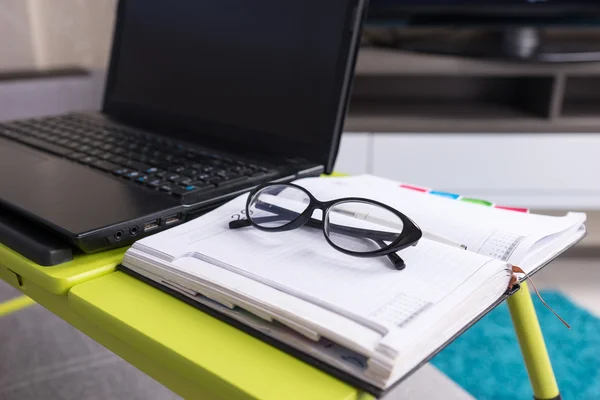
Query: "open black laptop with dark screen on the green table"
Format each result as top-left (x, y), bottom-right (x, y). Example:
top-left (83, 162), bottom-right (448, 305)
top-left (0, 0), bottom-right (366, 253)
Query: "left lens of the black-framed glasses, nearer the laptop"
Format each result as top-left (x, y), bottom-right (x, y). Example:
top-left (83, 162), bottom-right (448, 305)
top-left (248, 185), bottom-right (310, 229)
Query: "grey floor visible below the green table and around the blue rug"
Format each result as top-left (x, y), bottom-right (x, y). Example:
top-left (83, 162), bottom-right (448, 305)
top-left (0, 257), bottom-right (600, 400)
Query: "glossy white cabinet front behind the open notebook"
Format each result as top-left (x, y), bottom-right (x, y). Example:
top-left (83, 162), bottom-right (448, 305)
top-left (336, 133), bottom-right (600, 209)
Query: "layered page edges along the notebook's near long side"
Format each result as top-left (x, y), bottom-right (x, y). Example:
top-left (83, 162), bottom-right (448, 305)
top-left (123, 245), bottom-right (381, 354)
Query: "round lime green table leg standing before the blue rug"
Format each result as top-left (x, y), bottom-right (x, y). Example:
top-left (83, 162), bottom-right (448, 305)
top-left (508, 282), bottom-right (561, 400)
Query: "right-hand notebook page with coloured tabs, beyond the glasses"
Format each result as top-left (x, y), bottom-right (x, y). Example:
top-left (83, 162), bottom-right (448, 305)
top-left (296, 175), bottom-right (585, 263)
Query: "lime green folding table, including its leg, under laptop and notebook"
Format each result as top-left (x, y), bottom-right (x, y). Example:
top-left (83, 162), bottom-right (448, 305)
top-left (0, 239), bottom-right (560, 400)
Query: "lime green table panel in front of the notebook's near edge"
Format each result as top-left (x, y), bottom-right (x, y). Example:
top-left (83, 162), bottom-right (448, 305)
top-left (68, 271), bottom-right (371, 400)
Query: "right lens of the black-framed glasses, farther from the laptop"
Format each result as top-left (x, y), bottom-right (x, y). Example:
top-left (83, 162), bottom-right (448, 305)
top-left (325, 201), bottom-right (404, 253)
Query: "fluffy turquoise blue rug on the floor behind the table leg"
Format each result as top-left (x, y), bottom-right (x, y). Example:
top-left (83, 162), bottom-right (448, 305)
top-left (432, 291), bottom-right (600, 400)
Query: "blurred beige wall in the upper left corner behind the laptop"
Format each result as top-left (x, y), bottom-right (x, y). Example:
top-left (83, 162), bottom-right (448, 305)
top-left (0, 0), bottom-right (117, 71)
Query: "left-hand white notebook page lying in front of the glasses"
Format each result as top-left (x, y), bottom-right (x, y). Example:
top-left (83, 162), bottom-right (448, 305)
top-left (138, 192), bottom-right (510, 334)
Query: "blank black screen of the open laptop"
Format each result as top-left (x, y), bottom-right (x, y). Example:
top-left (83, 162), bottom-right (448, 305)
top-left (104, 0), bottom-right (357, 170)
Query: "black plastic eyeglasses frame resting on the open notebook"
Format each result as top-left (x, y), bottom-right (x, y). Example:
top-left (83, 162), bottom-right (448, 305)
top-left (229, 183), bottom-right (423, 270)
